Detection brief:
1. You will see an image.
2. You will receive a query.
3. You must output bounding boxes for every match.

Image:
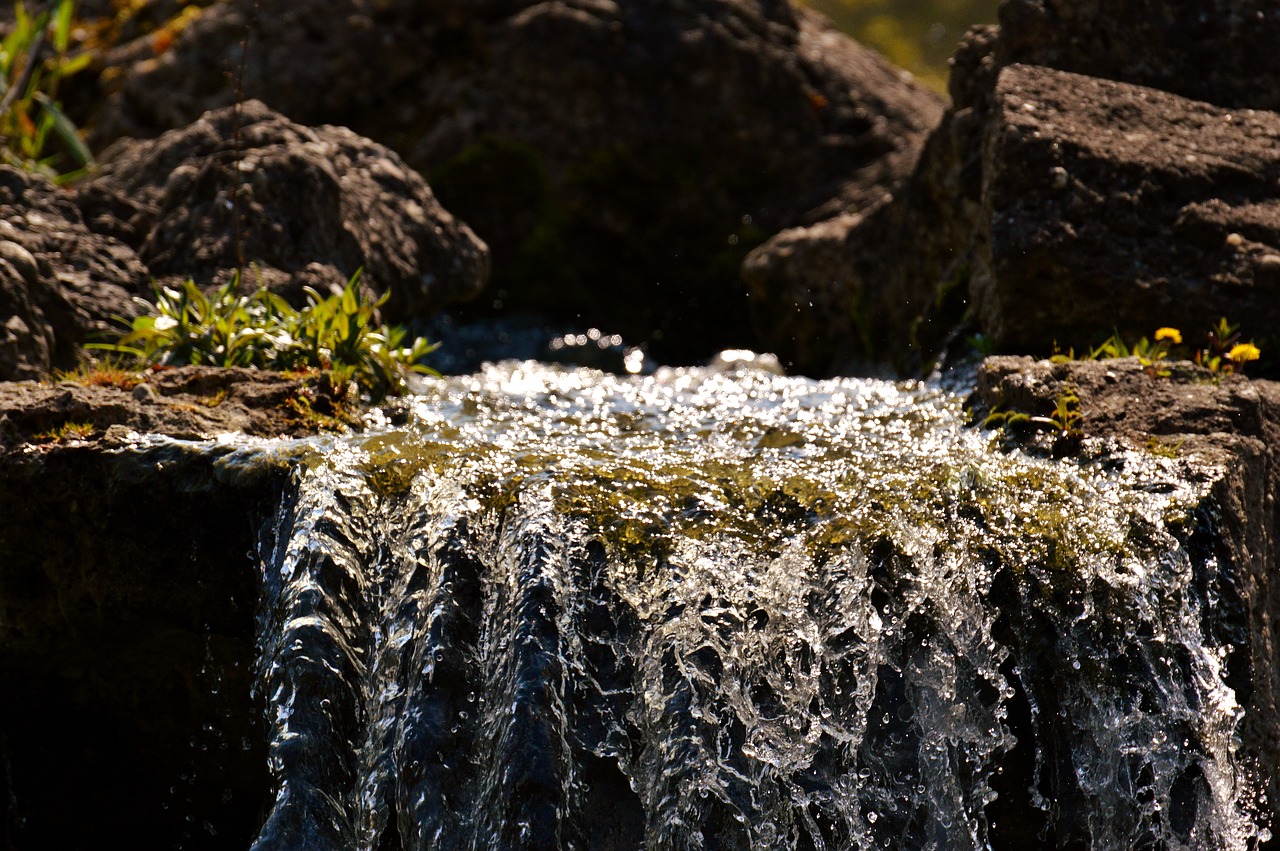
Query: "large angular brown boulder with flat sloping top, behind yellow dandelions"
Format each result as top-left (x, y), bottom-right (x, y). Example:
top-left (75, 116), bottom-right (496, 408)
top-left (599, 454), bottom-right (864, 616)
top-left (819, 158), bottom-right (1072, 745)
top-left (969, 65), bottom-right (1280, 352)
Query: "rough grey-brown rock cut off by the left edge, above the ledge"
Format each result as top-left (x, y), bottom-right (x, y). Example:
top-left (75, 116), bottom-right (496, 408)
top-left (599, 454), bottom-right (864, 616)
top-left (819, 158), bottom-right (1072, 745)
top-left (0, 166), bottom-right (147, 380)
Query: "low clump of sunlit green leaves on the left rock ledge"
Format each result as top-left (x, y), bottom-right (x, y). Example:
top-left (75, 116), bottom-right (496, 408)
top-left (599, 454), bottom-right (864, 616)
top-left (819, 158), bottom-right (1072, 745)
top-left (91, 271), bottom-right (435, 398)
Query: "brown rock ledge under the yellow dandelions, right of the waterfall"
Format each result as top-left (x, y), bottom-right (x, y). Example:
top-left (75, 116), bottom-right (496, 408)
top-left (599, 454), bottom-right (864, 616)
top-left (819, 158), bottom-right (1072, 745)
top-left (969, 357), bottom-right (1280, 813)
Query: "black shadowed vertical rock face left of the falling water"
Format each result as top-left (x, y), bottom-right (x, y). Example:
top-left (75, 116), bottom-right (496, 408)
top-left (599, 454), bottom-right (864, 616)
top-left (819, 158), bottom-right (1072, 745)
top-left (0, 435), bottom-right (288, 851)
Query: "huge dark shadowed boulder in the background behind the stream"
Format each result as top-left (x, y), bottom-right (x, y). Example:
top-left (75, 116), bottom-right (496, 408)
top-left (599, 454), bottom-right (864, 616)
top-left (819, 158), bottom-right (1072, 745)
top-left (82, 0), bottom-right (941, 358)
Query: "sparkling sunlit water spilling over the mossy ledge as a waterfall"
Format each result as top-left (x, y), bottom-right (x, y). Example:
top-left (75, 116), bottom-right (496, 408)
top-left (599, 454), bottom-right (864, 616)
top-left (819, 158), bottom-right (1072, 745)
top-left (244, 363), bottom-right (1263, 851)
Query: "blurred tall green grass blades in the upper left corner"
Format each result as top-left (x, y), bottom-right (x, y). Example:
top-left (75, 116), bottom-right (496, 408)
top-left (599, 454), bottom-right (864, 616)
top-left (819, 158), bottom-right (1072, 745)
top-left (0, 0), bottom-right (93, 183)
